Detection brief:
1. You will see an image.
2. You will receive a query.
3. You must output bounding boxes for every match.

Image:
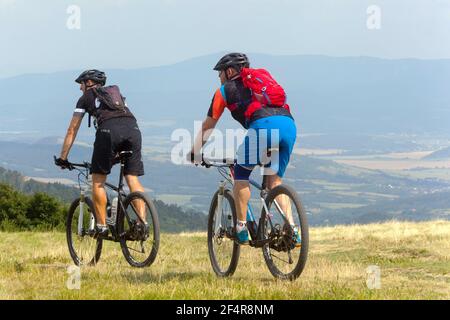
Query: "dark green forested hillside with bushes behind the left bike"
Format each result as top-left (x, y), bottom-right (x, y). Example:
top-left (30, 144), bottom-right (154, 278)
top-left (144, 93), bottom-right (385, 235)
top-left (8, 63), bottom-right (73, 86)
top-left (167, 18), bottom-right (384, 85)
top-left (0, 168), bottom-right (206, 232)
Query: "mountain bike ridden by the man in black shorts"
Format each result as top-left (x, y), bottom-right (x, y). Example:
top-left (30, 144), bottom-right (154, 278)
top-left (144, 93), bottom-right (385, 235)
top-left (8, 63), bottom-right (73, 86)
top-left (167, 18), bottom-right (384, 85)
top-left (55, 151), bottom-right (160, 268)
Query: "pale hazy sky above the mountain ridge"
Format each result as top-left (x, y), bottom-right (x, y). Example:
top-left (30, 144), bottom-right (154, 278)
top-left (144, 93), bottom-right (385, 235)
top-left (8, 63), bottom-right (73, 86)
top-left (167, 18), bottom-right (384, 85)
top-left (0, 0), bottom-right (450, 77)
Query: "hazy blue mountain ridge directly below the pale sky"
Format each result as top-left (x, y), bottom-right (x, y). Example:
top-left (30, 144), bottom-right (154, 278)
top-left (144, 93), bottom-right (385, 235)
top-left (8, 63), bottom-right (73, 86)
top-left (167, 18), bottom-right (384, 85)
top-left (0, 54), bottom-right (450, 135)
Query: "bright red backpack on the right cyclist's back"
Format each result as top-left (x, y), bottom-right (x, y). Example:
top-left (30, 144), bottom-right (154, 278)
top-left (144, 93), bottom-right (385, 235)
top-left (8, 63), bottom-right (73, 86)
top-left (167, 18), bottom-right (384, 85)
top-left (241, 68), bottom-right (289, 119)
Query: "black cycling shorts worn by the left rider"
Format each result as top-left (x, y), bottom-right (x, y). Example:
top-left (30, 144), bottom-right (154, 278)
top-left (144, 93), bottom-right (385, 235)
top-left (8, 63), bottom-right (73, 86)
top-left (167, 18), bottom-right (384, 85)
top-left (91, 118), bottom-right (144, 176)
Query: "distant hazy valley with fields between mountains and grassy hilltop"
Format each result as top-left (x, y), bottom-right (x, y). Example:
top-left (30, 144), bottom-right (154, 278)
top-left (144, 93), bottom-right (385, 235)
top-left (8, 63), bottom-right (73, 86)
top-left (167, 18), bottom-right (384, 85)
top-left (0, 134), bottom-right (450, 225)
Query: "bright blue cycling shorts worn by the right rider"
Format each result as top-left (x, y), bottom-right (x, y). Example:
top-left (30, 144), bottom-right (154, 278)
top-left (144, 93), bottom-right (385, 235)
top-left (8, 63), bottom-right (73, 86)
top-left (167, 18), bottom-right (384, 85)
top-left (234, 116), bottom-right (297, 180)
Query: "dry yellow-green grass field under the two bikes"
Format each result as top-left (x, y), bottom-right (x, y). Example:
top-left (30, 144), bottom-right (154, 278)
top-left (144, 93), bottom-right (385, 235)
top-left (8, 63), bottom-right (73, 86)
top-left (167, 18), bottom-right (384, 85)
top-left (0, 221), bottom-right (450, 299)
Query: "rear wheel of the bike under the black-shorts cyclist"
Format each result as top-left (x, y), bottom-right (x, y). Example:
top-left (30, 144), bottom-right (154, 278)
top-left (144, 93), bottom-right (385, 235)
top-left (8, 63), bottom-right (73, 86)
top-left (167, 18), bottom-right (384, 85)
top-left (118, 192), bottom-right (159, 268)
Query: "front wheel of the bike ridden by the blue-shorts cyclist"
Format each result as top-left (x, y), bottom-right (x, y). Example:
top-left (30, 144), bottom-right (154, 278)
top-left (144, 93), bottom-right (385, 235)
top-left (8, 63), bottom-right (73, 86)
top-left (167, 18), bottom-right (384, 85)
top-left (208, 190), bottom-right (240, 277)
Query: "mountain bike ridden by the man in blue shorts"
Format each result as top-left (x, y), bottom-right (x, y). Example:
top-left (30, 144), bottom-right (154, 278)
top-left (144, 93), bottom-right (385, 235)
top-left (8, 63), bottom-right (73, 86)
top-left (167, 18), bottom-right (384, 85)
top-left (200, 158), bottom-right (309, 280)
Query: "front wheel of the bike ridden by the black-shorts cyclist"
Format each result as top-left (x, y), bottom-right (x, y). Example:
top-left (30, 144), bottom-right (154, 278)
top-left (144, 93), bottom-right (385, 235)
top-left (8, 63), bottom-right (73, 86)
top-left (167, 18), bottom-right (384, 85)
top-left (66, 198), bottom-right (103, 266)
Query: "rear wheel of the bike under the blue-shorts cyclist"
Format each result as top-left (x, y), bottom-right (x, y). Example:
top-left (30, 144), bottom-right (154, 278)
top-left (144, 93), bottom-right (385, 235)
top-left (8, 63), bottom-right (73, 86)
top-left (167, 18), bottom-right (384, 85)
top-left (261, 185), bottom-right (309, 280)
